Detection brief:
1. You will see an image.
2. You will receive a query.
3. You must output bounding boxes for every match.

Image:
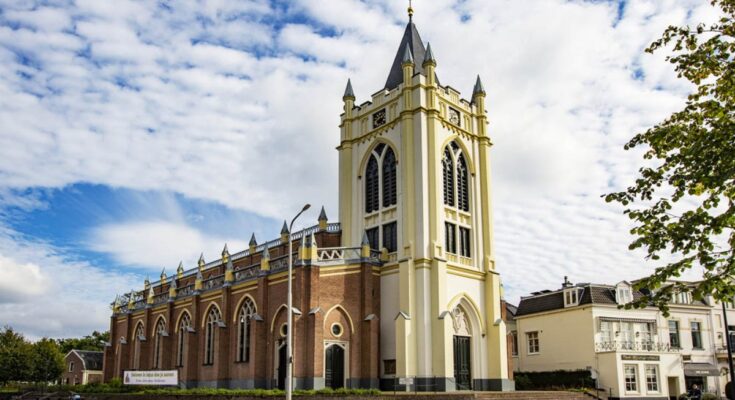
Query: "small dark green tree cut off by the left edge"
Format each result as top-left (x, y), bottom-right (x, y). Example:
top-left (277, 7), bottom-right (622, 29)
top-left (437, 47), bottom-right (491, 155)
top-left (0, 326), bottom-right (32, 385)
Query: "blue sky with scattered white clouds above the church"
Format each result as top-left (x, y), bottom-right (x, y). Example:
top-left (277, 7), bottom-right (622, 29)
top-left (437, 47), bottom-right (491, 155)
top-left (0, 0), bottom-right (717, 338)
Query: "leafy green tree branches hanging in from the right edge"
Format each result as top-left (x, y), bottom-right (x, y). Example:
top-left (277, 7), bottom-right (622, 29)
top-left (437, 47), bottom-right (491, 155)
top-left (605, 0), bottom-right (735, 314)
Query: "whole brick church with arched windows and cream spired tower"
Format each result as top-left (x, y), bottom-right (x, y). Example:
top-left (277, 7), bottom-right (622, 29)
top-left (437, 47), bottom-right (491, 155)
top-left (104, 8), bottom-right (514, 391)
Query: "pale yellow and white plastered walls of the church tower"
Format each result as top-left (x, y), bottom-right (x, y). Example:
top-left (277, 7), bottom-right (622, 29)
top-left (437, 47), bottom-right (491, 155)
top-left (337, 44), bottom-right (508, 390)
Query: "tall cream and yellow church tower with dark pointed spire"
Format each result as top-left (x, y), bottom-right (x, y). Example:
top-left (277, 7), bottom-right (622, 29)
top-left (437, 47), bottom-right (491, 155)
top-left (338, 8), bottom-right (513, 391)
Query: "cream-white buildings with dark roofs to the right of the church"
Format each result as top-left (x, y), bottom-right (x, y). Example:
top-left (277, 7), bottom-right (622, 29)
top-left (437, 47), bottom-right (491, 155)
top-left (511, 279), bottom-right (735, 399)
